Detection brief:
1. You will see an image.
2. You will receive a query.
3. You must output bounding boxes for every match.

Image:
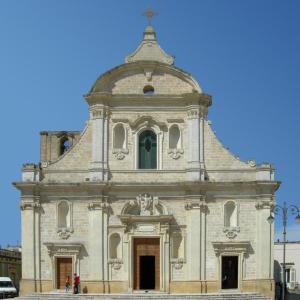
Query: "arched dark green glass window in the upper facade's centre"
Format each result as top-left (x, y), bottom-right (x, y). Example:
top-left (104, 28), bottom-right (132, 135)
top-left (139, 130), bottom-right (157, 169)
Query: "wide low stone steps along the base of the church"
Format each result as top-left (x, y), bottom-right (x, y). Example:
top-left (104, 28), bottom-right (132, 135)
top-left (18, 292), bottom-right (270, 300)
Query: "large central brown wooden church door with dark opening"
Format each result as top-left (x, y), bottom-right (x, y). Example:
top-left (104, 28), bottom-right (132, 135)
top-left (134, 238), bottom-right (160, 290)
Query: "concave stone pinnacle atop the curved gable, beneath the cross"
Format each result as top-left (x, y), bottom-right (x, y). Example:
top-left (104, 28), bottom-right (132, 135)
top-left (125, 25), bottom-right (174, 65)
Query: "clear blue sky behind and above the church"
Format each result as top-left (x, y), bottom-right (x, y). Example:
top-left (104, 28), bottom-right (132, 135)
top-left (0, 0), bottom-right (300, 246)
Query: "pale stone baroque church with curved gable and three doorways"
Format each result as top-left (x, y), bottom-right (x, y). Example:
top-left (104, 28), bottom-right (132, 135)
top-left (14, 25), bottom-right (279, 298)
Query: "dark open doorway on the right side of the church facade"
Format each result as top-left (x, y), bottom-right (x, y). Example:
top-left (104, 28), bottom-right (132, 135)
top-left (222, 256), bottom-right (238, 289)
